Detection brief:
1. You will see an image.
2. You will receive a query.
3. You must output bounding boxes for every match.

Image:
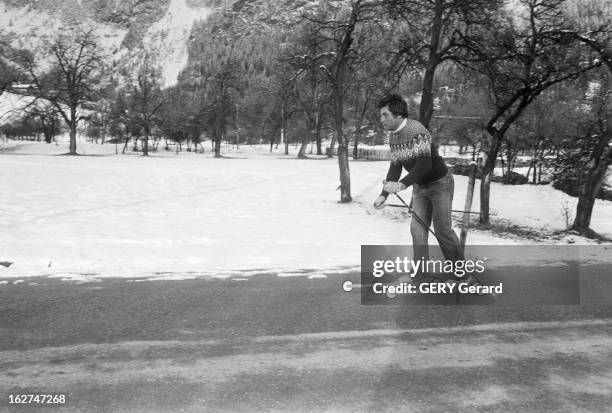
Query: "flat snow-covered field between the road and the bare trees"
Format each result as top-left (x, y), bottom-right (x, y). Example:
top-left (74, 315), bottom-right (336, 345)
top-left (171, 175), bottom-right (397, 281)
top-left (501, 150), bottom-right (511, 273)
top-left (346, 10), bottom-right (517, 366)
top-left (0, 141), bottom-right (612, 280)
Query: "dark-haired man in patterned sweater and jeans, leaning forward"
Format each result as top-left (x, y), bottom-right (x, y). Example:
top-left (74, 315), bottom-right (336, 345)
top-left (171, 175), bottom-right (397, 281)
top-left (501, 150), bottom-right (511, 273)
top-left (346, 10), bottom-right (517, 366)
top-left (374, 94), bottom-right (464, 274)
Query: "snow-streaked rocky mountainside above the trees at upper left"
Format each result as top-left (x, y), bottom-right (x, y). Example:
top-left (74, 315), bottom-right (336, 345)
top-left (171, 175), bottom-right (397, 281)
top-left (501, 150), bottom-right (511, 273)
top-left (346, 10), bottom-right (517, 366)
top-left (0, 0), bottom-right (215, 86)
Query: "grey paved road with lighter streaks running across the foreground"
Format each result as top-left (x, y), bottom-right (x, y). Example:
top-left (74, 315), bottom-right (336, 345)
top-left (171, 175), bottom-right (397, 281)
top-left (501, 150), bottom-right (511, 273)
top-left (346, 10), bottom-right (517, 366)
top-left (0, 274), bottom-right (612, 412)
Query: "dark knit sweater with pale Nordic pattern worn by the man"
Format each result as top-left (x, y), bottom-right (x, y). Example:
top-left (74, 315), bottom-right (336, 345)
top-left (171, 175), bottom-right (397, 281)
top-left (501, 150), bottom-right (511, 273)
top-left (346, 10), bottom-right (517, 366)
top-left (381, 119), bottom-right (448, 197)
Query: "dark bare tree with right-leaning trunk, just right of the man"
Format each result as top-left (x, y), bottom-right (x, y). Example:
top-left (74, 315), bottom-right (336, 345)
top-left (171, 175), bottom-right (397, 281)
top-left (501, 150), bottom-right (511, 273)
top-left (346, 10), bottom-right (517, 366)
top-left (461, 0), bottom-right (600, 224)
